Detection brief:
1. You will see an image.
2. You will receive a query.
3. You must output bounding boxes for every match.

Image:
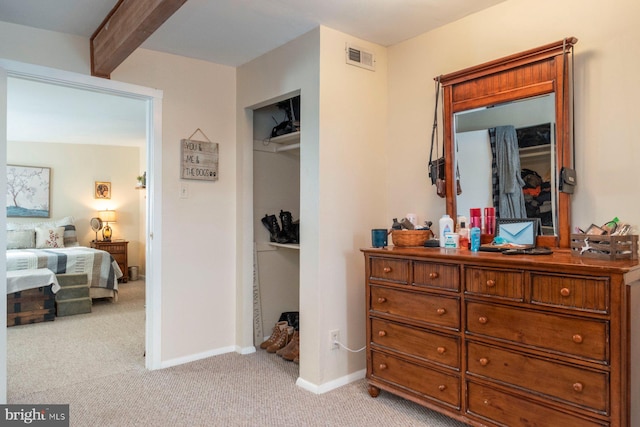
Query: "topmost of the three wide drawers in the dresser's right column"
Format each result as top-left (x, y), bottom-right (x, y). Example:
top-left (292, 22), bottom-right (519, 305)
top-left (467, 302), bottom-right (609, 362)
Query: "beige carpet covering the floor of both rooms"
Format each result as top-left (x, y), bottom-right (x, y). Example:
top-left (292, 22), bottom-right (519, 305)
top-left (7, 281), bottom-right (463, 427)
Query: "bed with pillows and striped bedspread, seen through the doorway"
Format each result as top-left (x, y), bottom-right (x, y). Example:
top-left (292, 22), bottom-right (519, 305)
top-left (7, 217), bottom-right (123, 301)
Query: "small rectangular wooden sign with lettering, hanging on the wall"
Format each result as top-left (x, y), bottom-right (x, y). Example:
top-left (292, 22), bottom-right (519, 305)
top-left (180, 139), bottom-right (218, 181)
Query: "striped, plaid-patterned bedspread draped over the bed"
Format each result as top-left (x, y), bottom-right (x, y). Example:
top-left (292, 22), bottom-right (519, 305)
top-left (7, 246), bottom-right (122, 290)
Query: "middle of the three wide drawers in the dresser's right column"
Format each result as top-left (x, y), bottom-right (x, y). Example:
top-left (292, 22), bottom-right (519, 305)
top-left (467, 342), bottom-right (609, 413)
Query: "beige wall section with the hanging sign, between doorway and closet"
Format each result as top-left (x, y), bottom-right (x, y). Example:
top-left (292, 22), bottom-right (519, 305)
top-left (111, 49), bottom-right (237, 365)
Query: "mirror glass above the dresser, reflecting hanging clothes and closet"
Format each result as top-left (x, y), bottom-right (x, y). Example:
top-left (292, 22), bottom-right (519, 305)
top-left (453, 93), bottom-right (558, 235)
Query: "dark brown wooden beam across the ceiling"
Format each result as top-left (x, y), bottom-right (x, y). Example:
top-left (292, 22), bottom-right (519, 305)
top-left (90, 0), bottom-right (187, 79)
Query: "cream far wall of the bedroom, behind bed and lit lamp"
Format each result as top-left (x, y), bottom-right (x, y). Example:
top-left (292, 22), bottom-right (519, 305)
top-left (7, 142), bottom-right (144, 265)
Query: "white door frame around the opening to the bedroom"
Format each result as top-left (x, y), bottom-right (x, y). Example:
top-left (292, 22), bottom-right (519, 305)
top-left (0, 58), bottom-right (163, 404)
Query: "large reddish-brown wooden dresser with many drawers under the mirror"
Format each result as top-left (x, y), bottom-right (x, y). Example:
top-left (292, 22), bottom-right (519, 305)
top-left (363, 248), bottom-right (640, 427)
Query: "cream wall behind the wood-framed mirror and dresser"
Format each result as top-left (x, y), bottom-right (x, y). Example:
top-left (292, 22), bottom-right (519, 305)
top-left (387, 0), bottom-right (640, 234)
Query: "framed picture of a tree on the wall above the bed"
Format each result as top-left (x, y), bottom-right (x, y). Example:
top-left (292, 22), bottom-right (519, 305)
top-left (7, 165), bottom-right (51, 218)
